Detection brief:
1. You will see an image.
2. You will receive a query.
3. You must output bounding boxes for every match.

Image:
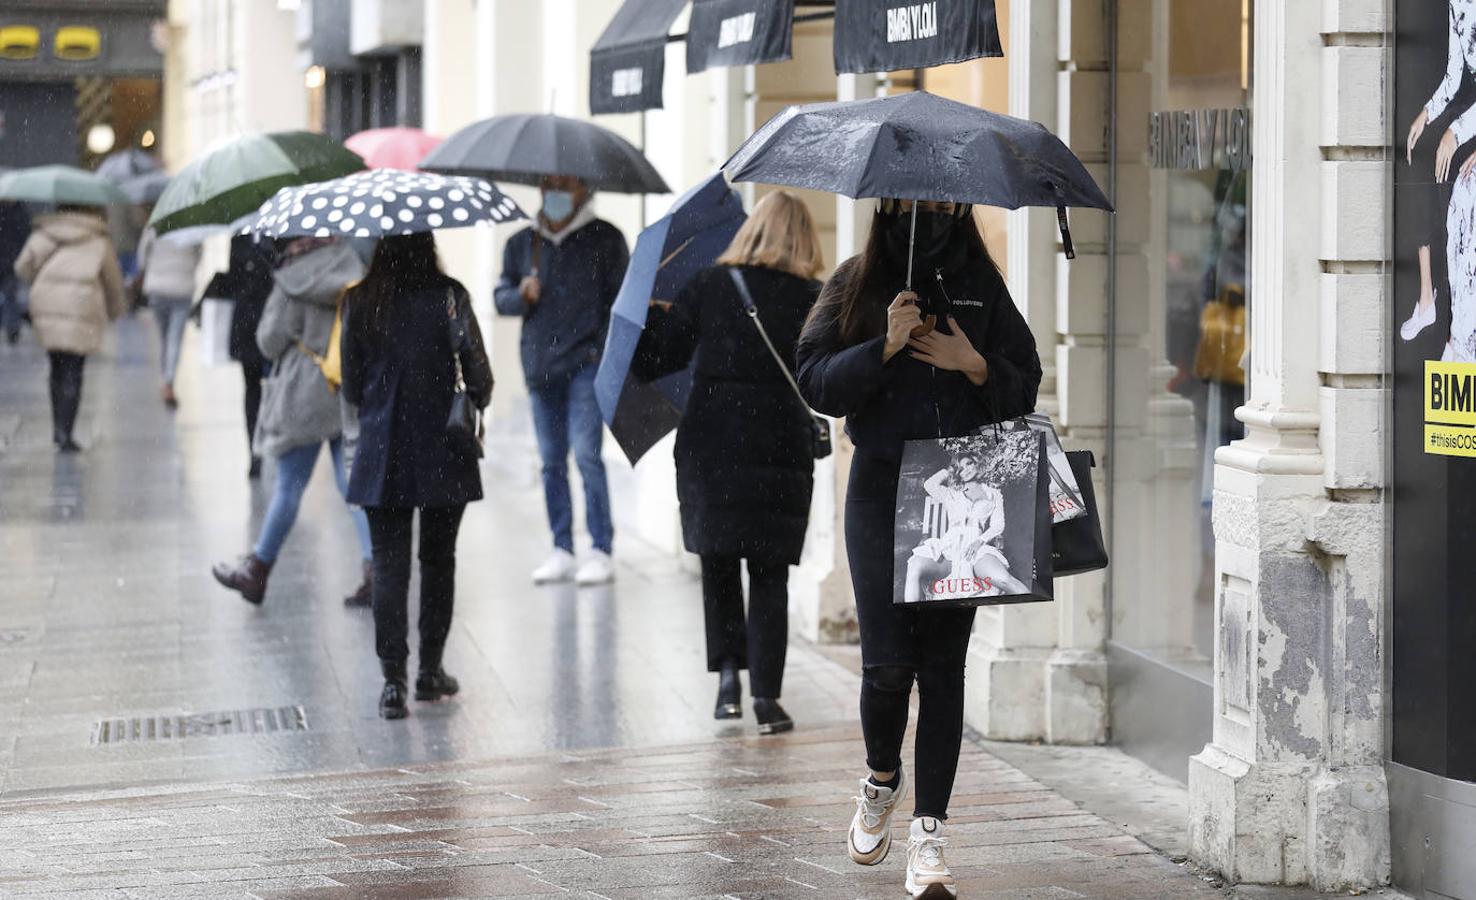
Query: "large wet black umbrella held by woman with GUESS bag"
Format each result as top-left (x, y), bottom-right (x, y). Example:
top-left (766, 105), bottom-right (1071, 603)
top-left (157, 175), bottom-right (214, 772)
top-left (723, 91), bottom-right (1111, 258)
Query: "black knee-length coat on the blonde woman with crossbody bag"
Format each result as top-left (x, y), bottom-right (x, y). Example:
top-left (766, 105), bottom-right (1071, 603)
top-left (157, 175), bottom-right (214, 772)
top-left (635, 266), bottom-right (819, 564)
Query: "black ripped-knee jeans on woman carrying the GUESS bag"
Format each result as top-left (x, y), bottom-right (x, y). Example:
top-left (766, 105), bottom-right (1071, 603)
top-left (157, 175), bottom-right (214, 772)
top-left (846, 451), bottom-right (974, 819)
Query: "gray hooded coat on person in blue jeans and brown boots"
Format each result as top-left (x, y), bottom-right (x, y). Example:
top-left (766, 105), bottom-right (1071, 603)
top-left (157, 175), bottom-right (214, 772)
top-left (255, 243), bottom-right (365, 456)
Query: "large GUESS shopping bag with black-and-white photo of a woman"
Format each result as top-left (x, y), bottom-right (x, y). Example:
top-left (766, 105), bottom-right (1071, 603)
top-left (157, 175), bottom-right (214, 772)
top-left (893, 428), bottom-right (1054, 608)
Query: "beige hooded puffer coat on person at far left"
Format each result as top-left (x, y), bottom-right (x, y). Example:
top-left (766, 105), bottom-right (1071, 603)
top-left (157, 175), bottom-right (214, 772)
top-left (15, 212), bottom-right (128, 356)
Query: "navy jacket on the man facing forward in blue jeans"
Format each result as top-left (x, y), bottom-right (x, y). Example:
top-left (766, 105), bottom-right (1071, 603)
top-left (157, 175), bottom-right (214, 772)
top-left (494, 218), bottom-right (630, 391)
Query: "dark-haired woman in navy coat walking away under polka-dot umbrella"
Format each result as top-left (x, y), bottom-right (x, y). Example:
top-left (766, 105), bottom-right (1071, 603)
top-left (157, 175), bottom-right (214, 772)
top-left (342, 232), bottom-right (492, 719)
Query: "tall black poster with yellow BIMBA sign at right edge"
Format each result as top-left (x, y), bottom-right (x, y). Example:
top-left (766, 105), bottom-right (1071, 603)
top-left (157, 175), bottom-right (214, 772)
top-left (1387, 0), bottom-right (1476, 780)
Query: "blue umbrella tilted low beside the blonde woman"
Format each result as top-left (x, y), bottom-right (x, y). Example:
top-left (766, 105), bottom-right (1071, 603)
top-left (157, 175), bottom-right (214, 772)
top-left (595, 173), bottom-right (747, 463)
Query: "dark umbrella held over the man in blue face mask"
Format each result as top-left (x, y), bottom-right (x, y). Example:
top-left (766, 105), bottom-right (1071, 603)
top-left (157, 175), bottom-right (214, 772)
top-left (421, 115), bottom-right (672, 193)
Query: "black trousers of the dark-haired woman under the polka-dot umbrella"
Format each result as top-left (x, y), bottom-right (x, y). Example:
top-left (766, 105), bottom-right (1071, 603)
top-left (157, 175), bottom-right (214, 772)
top-left (365, 505), bottom-right (466, 671)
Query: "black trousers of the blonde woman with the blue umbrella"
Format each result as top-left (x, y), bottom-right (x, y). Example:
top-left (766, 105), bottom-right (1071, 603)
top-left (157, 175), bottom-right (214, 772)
top-left (703, 555), bottom-right (790, 699)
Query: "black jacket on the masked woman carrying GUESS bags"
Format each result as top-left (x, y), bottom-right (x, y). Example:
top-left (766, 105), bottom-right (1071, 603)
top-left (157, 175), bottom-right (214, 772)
top-left (797, 246), bottom-right (1041, 462)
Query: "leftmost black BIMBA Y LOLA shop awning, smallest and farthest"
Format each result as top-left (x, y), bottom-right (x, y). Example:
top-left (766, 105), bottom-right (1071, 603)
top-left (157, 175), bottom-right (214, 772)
top-left (589, 0), bottom-right (689, 112)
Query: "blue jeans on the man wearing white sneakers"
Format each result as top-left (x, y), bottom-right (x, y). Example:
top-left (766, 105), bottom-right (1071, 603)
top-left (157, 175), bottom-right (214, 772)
top-left (528, 363), bottom-right (615, 553)
